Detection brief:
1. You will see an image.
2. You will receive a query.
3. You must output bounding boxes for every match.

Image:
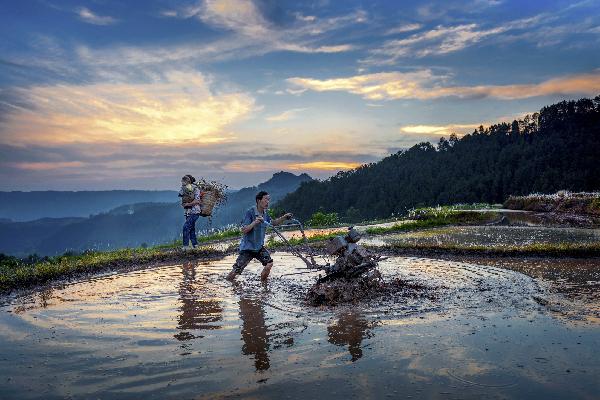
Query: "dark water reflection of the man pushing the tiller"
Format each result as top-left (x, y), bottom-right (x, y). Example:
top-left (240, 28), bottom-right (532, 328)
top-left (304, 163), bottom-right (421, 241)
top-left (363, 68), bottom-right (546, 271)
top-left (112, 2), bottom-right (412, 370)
top-left (240, 297), bottom-right (270, 371)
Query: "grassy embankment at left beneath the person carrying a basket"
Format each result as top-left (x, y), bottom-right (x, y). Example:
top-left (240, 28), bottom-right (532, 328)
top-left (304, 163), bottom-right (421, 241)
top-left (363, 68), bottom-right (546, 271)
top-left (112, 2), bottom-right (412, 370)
top-left (0, 228), bottom-right (240, 292)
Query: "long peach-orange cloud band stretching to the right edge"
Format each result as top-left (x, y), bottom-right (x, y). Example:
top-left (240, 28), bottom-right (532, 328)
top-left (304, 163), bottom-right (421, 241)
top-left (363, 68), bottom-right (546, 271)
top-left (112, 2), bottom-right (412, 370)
top-left (287, 70), bottom-right (600, 100)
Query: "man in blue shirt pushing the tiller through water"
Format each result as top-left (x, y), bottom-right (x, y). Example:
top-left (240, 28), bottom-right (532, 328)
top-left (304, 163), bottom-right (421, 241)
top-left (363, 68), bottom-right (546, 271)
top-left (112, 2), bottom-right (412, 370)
top-left (227, 191), bottom-right (292, 281)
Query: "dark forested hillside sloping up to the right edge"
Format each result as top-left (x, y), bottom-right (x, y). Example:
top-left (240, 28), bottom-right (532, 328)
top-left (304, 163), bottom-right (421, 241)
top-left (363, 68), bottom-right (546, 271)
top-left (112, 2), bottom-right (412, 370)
top-left (278, 96), bottom-right (600, 221)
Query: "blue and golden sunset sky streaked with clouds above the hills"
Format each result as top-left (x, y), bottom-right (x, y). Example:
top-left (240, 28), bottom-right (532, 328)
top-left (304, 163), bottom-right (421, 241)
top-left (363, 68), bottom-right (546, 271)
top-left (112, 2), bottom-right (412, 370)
top-left (0, 0), bottom-right (600, 191)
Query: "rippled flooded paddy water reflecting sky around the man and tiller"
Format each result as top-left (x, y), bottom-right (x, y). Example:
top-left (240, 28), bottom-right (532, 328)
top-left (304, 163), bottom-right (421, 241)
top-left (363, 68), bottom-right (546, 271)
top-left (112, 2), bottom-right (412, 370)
top-left (0, 253), bottom-right (600, 399)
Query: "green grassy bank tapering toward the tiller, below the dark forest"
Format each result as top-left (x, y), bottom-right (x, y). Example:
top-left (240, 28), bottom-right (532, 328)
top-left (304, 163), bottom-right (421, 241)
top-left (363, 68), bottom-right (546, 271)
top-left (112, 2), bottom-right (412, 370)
top-left (366, 205), bottom-right (499, 235)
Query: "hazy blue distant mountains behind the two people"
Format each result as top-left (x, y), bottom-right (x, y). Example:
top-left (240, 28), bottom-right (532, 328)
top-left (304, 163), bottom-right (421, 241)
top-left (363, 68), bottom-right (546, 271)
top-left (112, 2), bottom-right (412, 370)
top-left (0, 172), bottom-right (312, 256)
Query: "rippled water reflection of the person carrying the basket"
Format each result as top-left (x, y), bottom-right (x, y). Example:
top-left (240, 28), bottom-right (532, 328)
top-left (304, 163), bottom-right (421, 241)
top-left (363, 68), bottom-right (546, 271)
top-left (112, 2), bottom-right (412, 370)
top-left (174, 262), bottom-right (223, 341)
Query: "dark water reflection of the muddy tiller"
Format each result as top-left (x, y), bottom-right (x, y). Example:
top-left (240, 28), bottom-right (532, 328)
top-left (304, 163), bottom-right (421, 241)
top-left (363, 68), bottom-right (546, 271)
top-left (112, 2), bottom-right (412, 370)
top-left (327, 311), bottom-right (374, 362)
